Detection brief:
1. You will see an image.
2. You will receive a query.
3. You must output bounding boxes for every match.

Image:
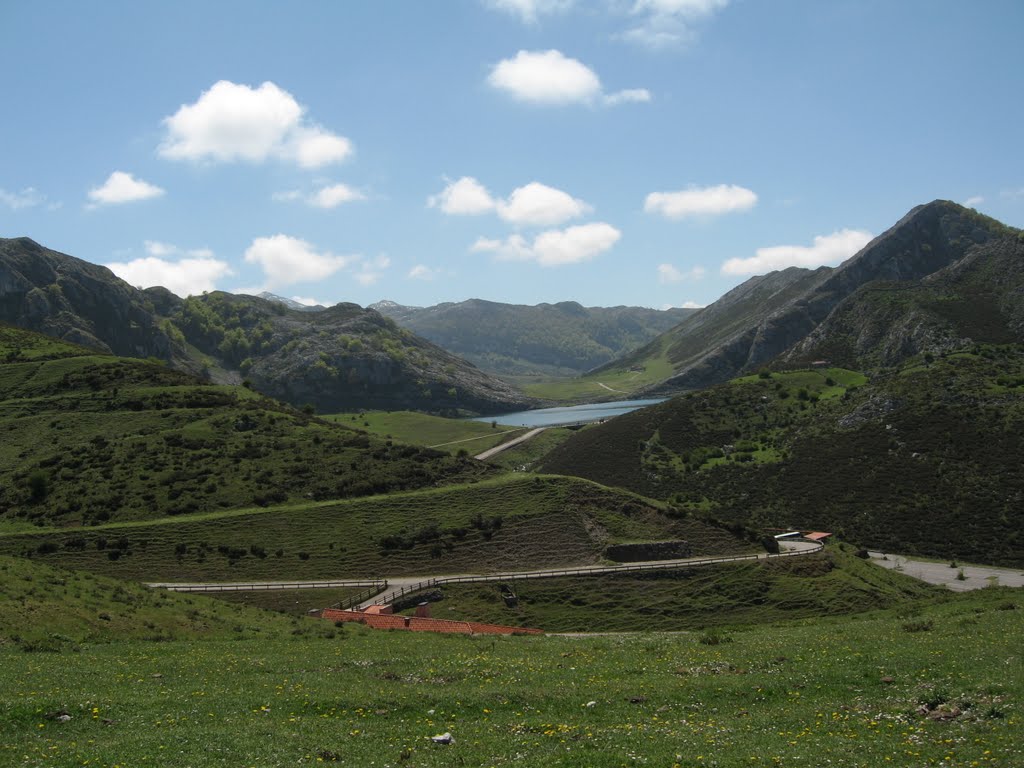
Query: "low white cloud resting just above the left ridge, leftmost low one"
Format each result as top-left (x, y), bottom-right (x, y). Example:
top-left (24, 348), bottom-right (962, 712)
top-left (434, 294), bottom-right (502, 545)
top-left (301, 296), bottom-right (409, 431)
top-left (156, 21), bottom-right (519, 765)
top-left (104, 241), bottom-right (233, 296)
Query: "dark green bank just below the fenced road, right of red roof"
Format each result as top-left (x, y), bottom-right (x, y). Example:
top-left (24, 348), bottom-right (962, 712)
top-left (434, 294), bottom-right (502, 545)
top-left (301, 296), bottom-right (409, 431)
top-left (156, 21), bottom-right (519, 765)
top-left (411, 549), bottom-right (942, 632)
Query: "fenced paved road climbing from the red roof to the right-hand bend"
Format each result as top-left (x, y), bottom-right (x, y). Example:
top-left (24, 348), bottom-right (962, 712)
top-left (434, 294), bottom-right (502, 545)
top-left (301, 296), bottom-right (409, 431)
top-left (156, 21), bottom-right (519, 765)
top-left (358, 541), bottom-right (822, 609)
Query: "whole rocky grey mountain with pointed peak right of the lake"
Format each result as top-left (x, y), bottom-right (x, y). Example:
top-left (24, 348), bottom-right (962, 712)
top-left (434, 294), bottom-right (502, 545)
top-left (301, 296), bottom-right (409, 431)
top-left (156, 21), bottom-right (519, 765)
top-left (594, 201), bottom-right (1020, 394)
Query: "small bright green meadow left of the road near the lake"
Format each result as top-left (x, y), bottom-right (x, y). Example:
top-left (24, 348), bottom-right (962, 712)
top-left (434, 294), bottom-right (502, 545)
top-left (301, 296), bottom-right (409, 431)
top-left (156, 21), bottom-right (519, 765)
top-left (324, 411), bottom-right (522, 456)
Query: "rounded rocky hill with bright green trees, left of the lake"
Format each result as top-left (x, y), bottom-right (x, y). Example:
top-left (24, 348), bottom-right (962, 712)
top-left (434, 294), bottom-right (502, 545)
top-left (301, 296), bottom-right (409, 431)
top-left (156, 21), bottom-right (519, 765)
top-left (169, 291), bottom-right (531, 414)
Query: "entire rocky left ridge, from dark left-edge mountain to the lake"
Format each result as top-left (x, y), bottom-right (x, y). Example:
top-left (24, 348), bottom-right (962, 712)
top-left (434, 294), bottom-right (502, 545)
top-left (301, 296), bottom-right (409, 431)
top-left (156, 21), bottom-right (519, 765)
top-left (0, 238), bottom-right (532, 414)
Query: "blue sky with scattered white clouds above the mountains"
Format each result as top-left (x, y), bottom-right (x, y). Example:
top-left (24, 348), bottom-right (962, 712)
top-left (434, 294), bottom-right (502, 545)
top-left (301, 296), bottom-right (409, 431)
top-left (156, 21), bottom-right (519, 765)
top-left (0, 0), bottom-right (1024, 307)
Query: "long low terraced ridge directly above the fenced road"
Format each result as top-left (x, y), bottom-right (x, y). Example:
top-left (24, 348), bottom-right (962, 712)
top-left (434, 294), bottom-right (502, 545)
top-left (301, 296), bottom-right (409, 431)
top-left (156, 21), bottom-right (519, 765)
top-left (0, 476), bottom-right (751, 582)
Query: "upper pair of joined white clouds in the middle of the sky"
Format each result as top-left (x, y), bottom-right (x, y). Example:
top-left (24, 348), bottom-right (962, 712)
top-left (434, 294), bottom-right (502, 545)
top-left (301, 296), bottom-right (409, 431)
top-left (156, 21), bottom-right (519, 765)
top-left (427, 176), bottom-right (591, 226)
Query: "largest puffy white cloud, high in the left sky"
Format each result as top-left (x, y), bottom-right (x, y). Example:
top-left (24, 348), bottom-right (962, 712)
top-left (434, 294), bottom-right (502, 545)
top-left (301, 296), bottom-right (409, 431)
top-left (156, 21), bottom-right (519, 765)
top-left (160, 80), bottom-right (352, 168)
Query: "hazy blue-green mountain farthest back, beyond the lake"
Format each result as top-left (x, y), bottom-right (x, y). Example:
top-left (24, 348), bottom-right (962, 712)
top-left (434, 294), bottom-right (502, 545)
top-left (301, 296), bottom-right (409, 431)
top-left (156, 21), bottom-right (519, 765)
top-left (371, 299), bottom-right (696, 376)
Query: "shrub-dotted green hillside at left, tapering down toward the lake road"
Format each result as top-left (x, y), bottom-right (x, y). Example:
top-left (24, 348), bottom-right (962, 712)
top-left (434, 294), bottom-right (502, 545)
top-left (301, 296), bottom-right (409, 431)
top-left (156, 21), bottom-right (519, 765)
top-left (0, 327), bottom-right (489, 524)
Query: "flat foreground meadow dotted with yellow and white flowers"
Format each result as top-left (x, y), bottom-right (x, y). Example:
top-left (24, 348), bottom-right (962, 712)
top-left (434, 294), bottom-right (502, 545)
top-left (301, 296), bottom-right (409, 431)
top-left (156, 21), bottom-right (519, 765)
top-left (0, 589), bottom-right (1024, 768)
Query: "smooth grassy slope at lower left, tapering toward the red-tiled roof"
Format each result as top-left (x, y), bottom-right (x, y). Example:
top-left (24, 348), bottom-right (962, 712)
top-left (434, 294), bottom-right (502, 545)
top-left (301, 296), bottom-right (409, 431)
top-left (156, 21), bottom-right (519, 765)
top-left (0, 557), bottom-right (317, 651)
